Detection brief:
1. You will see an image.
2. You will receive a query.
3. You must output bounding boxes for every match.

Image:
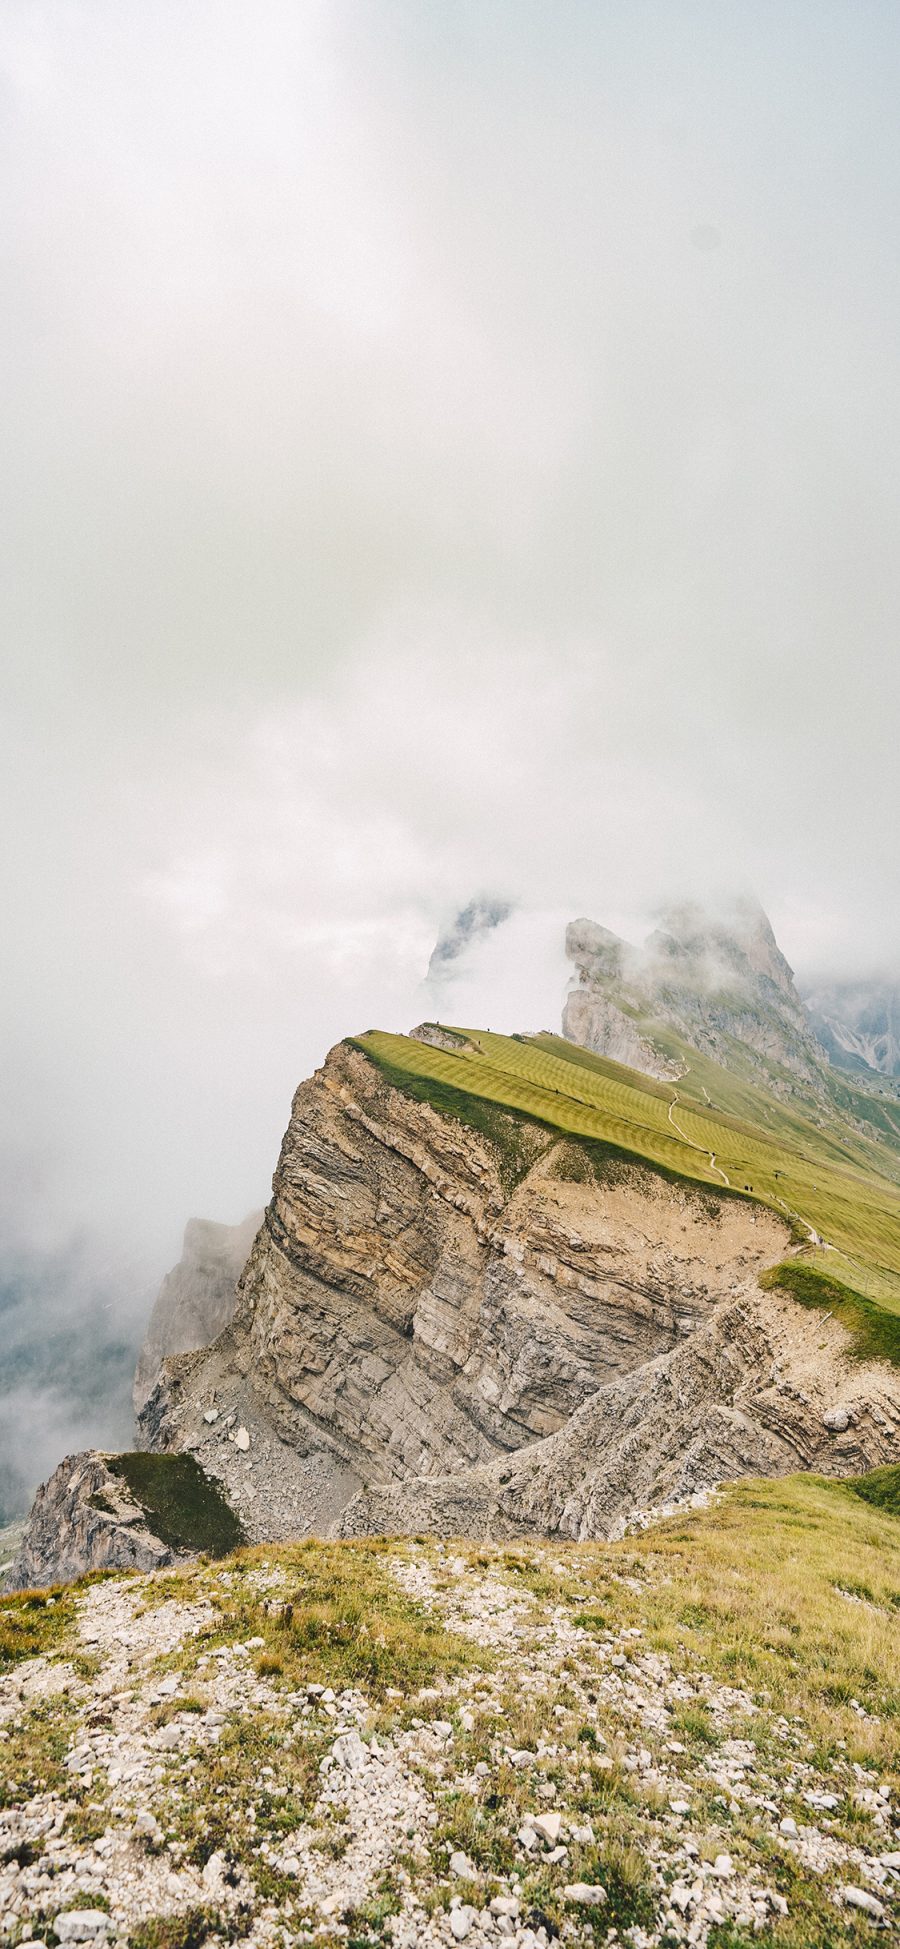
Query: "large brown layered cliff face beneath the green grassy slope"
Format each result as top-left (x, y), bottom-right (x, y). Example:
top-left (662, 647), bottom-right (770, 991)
top-left (140, 1045), bottom-right (900, 1538)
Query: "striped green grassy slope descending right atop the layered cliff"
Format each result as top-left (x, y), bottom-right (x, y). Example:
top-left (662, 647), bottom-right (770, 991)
top-left (356, 1029), bottom-right (900, 1314)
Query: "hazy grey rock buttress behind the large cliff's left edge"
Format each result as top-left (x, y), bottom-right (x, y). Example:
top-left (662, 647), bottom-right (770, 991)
top-left (134, 1212), bottom-right (263, 1411)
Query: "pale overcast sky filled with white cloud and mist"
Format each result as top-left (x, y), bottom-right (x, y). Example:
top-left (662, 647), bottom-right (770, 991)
top-left (0, 0), bottom-right (900, 1269)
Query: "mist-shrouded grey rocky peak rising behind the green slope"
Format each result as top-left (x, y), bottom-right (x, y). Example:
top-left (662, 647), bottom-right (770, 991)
top-left (563, 900), bottom-right (828, 1093)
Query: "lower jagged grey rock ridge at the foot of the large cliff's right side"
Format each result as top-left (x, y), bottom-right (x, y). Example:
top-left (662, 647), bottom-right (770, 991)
top-left (341, 1292), bottom-right (900, 1540)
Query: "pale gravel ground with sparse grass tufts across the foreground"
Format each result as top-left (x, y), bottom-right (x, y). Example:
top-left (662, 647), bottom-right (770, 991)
top-left (0, 1540), bottom-right (900, 1949)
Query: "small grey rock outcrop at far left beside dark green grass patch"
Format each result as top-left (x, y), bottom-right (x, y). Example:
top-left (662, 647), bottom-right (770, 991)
top-left (4, 1448), bottom-right (177, 1590)
